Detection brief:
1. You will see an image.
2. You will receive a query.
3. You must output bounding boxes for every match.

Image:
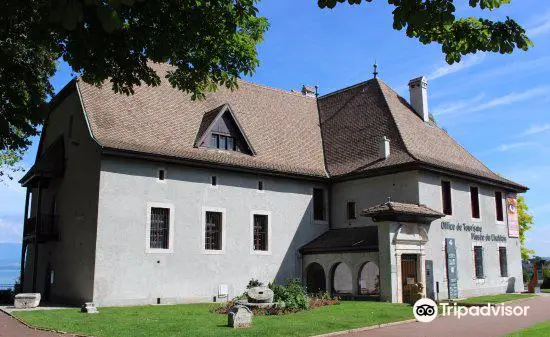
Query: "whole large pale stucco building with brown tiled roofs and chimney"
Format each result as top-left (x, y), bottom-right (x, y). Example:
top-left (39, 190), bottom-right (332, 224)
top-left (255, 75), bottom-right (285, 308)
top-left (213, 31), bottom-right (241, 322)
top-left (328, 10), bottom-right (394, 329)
top-left (21, 65), bottom-right (527, 306)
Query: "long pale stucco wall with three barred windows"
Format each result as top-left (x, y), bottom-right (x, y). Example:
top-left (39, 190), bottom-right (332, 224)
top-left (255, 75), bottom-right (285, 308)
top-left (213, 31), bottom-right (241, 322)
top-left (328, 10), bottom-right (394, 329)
top-left (94, 157), bottom-right (328, 306)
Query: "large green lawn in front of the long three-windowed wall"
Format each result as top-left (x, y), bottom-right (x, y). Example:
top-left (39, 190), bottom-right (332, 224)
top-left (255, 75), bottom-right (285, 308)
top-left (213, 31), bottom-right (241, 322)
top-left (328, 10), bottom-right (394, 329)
top-left (14, 302), bottom-right (413, 337)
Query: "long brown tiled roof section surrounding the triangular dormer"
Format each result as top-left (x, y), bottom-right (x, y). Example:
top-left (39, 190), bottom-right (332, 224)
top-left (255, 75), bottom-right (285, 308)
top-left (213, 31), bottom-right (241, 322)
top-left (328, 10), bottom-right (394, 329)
top-left (77, 65), bottom-right (327, 177)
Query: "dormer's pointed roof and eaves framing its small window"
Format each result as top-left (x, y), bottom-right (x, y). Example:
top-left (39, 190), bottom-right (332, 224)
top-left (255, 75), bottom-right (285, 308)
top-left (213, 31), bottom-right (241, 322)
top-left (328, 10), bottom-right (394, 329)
top-left (195, 104), bottom-right (256, 155)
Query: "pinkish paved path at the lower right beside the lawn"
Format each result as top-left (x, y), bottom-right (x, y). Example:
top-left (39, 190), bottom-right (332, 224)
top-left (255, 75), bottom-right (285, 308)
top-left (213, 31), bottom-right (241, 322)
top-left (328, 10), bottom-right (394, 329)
top-left (354, 296), bottom-right (550, 337)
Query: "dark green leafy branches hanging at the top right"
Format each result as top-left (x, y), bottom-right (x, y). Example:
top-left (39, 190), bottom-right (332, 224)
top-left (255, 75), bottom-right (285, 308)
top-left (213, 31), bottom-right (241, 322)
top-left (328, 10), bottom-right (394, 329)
top-left (318, 0), bottom-right (533, 64)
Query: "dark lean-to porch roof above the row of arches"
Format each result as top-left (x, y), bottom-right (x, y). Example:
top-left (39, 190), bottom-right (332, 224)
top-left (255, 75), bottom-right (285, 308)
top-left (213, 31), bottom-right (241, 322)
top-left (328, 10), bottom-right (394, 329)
top-left (300, 226), bottom-right (378, 254)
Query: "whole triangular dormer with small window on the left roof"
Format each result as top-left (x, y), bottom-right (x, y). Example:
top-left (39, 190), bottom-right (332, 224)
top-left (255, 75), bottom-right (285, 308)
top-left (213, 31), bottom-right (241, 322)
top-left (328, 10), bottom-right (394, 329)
top-left (195, 104), bottom-right (255, 155)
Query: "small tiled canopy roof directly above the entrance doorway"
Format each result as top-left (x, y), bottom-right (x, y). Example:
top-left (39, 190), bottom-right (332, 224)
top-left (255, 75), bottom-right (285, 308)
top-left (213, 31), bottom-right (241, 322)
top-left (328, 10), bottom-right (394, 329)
top-left (361, 201), bottom-right (445, 223)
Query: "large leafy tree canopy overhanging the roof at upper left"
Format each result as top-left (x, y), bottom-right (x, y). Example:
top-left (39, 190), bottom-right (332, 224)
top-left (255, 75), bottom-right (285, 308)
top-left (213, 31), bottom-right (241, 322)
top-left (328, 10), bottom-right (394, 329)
top-left (0, 0), bottom-right (268, 176)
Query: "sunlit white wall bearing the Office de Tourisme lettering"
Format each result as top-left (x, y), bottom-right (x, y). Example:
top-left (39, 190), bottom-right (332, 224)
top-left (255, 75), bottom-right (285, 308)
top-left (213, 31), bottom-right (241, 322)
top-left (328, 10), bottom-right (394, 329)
top-left (419, 173), bottom-right (523, 299)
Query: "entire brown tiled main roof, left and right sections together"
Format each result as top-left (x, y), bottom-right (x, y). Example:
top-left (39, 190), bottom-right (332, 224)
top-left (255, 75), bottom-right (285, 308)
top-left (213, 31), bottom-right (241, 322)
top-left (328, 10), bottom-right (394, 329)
top-left (72, 64), bottom-right (526, 190)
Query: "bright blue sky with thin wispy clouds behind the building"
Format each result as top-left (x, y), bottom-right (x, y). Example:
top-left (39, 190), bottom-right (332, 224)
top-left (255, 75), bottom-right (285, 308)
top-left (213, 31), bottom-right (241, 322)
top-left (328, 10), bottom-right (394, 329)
top-left (0, 0), bottom-right (550, 256)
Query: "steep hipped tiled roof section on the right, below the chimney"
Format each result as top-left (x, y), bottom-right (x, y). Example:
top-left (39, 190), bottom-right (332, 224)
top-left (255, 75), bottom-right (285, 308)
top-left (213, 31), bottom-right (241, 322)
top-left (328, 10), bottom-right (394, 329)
top-left (319, 79), bottom-right (527, 190)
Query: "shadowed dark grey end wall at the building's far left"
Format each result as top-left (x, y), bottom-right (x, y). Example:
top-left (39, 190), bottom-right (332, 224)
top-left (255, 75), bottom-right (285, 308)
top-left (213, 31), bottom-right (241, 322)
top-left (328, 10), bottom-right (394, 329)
top-left (24, 91), bottom-right (99, 305)
